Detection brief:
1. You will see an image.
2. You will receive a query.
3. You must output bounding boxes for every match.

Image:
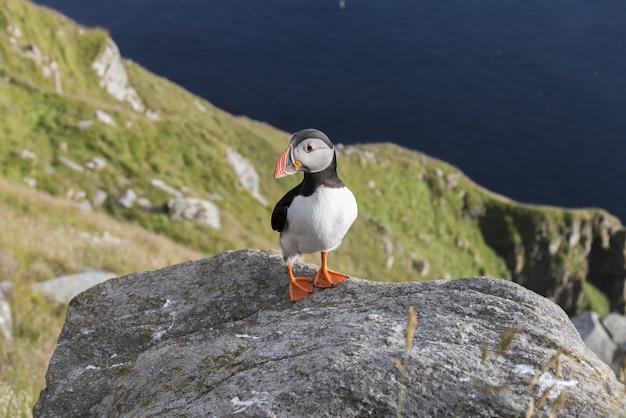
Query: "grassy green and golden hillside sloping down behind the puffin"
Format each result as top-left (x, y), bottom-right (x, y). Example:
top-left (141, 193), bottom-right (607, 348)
top-left (0, 0), bottom-right (623, 415)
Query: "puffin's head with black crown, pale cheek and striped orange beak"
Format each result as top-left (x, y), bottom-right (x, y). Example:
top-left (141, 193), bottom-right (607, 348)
top-left (274, 129), bottom-right (335, 179)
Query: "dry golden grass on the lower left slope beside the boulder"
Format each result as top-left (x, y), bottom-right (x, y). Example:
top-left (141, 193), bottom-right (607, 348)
top-left (0, 179), bottom-right (203, 417)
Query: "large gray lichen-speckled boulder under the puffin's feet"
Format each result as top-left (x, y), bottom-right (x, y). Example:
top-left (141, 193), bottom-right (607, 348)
top-left (34, 250), bottom-right (626, 417)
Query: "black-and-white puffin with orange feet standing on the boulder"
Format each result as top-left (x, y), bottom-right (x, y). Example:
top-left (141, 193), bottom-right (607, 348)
top-left (272, 129), bottom-right (358, 302)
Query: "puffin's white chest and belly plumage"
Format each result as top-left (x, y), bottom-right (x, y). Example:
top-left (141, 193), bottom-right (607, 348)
top-left (280, 186), bottom-right (358, 254)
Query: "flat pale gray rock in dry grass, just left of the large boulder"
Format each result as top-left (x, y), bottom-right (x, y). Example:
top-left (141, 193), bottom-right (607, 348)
top-left (33, 268), bottom-right (117, 304)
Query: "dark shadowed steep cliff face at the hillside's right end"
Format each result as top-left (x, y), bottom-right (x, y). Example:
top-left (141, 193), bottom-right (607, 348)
top-left (479, 200), bottom-right (626, 315)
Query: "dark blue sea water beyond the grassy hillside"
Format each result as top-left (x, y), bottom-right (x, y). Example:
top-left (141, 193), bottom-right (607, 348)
top-left (34, 0), bottom-right (626, 220)
